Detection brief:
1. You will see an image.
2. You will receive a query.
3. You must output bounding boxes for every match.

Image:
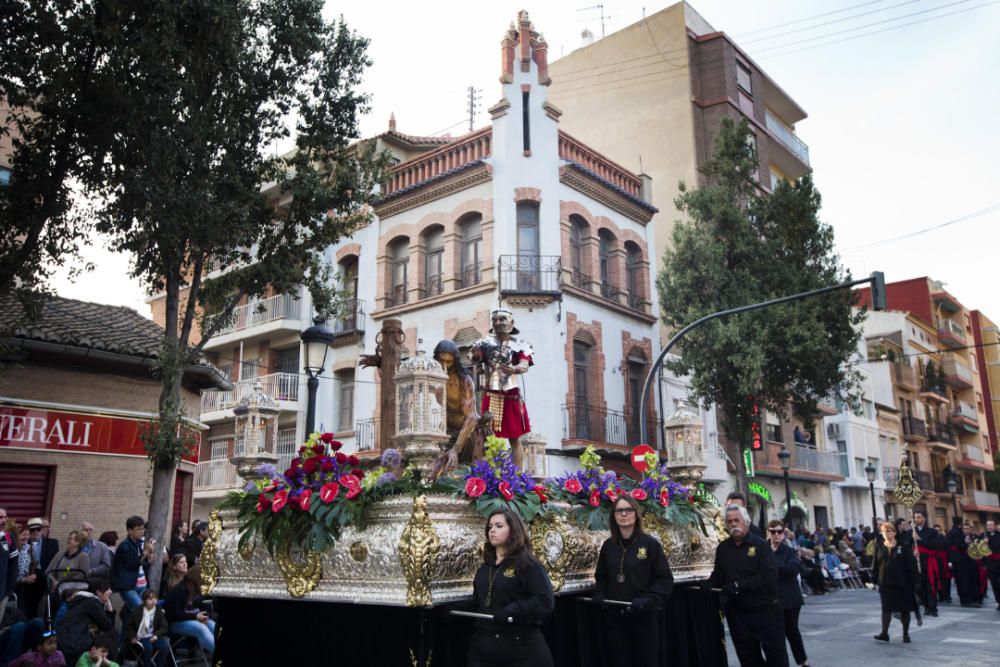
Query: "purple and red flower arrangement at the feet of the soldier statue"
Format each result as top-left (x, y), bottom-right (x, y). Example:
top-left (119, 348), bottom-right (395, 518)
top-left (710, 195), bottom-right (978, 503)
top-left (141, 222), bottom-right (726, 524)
top-left (439, 435), bottom-right (550, 523)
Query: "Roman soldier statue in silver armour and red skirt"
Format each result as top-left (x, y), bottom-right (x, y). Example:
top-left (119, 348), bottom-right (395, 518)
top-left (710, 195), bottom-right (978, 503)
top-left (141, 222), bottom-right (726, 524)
top-left (470, 308), bottom-right (534, 468)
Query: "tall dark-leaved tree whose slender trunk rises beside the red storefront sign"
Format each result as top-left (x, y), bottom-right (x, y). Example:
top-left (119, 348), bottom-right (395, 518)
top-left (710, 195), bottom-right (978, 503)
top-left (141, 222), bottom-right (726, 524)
top-left (72, 0), bottom-right (384, 587)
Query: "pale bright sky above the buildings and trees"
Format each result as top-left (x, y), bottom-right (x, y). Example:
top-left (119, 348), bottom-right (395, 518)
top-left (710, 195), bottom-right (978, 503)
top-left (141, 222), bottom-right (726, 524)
top-left (53, 0), bottom-right (1000, 320)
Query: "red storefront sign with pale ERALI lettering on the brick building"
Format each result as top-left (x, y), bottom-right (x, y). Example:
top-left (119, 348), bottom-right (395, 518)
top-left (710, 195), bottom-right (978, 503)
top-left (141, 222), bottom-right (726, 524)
top-left (0, 405), bottom-right (201, 463)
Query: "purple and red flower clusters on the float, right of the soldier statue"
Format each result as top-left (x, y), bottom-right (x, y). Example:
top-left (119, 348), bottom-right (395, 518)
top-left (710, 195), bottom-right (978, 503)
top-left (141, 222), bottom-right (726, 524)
top-left (548, 445), bottom-right (711, 534)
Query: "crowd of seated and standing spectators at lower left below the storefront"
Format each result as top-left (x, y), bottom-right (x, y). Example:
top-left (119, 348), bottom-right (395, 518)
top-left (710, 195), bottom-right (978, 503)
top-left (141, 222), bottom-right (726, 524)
top-left (0, 508), bottom-right (215, 667)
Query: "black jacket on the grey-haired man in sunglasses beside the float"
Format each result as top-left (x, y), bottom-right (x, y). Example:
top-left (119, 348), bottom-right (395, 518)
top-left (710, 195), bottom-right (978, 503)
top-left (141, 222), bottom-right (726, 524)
top-left (708, 533), bottom-right (778, 612)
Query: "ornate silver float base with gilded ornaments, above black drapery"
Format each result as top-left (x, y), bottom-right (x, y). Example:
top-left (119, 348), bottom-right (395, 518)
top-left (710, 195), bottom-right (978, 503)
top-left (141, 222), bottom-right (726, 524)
top-left (202, 495), bottom-right (724, 607)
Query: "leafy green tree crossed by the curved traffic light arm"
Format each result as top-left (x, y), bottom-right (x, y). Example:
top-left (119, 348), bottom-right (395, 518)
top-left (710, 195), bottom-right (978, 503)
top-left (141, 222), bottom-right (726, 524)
top-left (657, 119), bottom-right (863, 496)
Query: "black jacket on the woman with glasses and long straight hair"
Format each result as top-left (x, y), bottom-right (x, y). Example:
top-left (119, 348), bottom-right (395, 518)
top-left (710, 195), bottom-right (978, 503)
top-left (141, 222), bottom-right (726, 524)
top-left (594, 533), bottom-right (674, 607)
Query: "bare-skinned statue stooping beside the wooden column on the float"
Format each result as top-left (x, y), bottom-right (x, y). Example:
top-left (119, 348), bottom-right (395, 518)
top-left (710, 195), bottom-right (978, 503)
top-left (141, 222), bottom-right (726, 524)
top-left (431, 339), bottom-right (492, 479)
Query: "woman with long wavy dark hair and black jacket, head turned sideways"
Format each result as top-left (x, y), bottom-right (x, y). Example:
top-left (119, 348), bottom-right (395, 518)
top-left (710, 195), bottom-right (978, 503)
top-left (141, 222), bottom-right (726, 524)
top-left (466, 509), bottom-right (555, 667)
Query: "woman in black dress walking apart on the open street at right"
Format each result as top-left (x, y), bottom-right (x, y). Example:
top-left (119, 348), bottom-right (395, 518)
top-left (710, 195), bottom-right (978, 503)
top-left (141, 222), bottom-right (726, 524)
top-left (873, 521), bottom-right (917, 644)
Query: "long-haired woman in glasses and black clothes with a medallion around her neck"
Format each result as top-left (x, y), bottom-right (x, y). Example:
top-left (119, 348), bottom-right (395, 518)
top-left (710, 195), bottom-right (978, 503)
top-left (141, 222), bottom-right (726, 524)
top-left (593, 494), bottom-right (674, 667)
